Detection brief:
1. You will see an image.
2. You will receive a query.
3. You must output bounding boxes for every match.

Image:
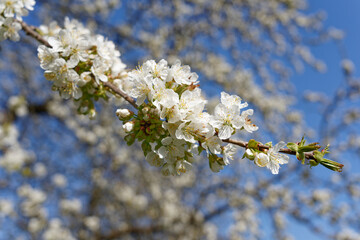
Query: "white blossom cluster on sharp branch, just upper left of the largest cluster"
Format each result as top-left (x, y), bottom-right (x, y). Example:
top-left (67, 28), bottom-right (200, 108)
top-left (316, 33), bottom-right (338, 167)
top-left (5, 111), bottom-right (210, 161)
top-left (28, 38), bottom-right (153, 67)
top-left (38, 18), bottom-right (125, 116)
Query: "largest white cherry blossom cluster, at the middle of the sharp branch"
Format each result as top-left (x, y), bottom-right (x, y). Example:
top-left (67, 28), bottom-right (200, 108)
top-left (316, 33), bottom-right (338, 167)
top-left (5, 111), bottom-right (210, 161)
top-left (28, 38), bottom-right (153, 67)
top-left (117, 60), bottom-right (258, 175)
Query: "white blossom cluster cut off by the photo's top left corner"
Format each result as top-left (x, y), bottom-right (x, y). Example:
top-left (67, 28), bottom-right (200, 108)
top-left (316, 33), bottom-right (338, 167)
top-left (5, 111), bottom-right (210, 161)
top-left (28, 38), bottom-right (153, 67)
top-left (0, 0), bottom-right (35, 41)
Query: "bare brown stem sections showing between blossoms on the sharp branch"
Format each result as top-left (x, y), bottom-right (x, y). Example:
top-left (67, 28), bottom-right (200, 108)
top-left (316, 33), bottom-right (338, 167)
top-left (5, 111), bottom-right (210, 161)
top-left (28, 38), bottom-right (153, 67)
top-left (18, 21), bottom-right (315, 162)
